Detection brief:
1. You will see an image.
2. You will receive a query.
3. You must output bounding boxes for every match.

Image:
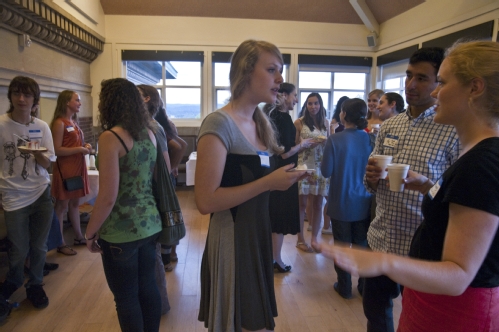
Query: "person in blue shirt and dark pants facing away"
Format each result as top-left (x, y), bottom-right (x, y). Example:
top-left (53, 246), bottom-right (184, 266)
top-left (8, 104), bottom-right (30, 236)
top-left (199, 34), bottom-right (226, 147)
top-left (321, 98), bottom-right (372, 299)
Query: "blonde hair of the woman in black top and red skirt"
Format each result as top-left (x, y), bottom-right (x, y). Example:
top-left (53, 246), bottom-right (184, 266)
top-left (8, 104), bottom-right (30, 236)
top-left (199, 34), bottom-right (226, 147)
top-left (445, 41), bottom-right (499, 124)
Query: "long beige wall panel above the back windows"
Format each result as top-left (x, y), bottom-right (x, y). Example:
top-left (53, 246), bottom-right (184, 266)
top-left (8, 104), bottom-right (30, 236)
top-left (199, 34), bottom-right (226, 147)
top-left (106, 15), bottom-right (369, 50)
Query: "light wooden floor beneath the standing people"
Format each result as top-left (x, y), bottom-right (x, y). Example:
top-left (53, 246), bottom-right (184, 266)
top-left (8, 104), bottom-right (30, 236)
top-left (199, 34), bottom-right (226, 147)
top-left (0, 187), bottom-right (401, 332)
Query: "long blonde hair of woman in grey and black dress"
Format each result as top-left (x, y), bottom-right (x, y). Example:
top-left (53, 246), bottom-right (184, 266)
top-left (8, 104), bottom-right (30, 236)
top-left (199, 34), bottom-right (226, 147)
top-left (229, 39), bottom-right (284, 154)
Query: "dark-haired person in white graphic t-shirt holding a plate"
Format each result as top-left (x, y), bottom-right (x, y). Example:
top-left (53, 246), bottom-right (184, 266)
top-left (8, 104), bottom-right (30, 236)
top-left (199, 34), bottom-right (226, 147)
top-left (0, 76), bottom-right (55, 308)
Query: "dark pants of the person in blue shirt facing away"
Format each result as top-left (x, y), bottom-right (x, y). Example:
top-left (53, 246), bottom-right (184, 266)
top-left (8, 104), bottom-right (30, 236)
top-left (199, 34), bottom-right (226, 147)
top-left (331, 219), bottom-right (369, 297)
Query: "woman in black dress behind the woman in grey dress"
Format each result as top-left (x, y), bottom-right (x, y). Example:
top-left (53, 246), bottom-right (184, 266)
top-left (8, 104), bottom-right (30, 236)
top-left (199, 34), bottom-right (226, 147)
top-left (264, 83), bottom-right (310, 273)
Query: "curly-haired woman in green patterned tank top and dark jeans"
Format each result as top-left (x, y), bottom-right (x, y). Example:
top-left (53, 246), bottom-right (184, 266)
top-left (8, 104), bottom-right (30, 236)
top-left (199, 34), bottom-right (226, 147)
top-left (85, 78), bottom-right (161, 332)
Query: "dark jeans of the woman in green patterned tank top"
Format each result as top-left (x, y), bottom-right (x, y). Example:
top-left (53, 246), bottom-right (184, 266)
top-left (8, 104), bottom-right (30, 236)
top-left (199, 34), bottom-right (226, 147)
top-left (99, 234), bottom-right (161, 332)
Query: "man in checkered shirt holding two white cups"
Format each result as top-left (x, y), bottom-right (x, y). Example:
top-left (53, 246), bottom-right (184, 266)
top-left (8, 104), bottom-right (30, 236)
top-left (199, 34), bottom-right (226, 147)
top-left (362, 47), bottom-right (459, 332)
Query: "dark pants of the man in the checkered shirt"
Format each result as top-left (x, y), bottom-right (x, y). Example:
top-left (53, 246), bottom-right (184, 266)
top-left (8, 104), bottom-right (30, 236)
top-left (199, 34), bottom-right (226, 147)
top-left (362, 276), bottom-right (400, 332)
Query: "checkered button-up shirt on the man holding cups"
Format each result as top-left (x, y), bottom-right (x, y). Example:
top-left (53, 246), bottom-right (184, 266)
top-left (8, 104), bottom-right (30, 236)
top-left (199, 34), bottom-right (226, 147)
top-left (364, 106), bottom-right (459, 256)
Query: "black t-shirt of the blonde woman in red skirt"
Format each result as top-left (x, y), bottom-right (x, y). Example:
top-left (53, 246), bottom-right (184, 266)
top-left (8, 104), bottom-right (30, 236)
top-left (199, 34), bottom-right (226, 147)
top-left (409, 138), bottom-right (499, 288)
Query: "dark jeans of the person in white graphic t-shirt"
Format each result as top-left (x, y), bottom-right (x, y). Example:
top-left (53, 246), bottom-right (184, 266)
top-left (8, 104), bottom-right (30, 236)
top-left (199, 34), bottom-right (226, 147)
top-left (4, 186), bottom-right (54, 288)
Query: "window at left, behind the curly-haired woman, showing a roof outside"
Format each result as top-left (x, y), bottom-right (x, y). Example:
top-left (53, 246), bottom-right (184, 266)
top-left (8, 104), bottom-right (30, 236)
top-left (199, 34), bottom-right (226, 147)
top-left (122, 50), bottom-right (204, 119)
